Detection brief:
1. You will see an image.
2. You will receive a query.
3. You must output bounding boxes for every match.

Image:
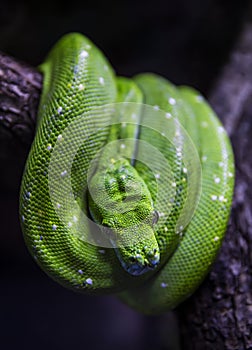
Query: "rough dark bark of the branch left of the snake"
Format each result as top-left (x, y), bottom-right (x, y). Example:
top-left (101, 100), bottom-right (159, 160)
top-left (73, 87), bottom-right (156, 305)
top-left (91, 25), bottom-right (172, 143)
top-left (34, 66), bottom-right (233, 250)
top-left (0, 52), bottom-right (42, 146)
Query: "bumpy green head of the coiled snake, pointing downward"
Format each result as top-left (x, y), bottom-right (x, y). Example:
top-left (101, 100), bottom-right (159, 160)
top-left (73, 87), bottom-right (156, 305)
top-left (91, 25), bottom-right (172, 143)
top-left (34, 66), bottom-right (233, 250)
top-left (88, 159), bottom-right (159, 276)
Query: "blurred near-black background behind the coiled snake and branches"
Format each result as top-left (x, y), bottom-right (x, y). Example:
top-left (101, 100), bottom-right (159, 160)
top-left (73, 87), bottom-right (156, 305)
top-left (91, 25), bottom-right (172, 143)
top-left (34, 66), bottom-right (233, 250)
top-left (0, 0), bottom-right (248, 350)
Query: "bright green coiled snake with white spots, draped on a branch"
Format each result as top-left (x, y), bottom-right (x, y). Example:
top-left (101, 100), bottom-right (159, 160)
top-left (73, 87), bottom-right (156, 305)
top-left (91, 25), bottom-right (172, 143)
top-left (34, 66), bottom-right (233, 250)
top-left (20, 33), bottom-right (234, 314)
